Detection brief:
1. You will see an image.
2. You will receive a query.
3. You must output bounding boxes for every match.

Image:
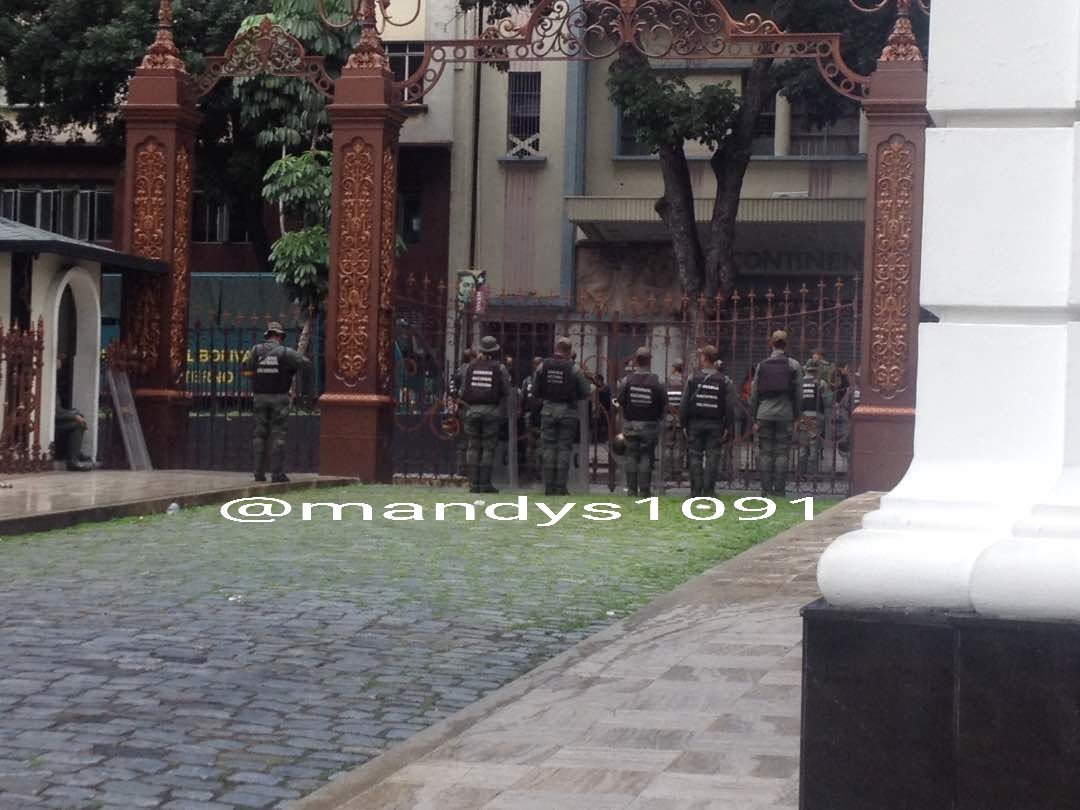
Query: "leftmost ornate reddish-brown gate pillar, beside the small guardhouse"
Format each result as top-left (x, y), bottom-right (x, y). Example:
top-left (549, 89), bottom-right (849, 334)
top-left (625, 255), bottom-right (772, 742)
top-left (121, 0), bottom-right (201, 468)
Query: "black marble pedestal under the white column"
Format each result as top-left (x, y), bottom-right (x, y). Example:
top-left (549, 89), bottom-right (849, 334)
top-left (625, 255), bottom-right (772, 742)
top-left (800, 604), bottom-right (1080, 810)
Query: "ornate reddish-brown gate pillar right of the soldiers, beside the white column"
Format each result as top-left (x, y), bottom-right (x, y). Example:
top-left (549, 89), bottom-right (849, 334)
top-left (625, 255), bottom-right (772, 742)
top-left (851, 17), bottom-right (930, 495)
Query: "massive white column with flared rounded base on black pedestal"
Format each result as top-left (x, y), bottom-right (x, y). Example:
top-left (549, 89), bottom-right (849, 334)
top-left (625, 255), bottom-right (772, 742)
top-left (818, 0), bottom-right (1080, 619)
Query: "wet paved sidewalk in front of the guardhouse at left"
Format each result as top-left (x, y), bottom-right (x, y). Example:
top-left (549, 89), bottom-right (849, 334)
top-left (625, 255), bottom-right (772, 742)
top-left (0, 470), bottom-right (351, 537)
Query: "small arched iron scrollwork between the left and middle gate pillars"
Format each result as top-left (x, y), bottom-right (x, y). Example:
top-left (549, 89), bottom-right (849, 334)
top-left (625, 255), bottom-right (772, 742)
top-left (194, 16), bottom-right (334, 98)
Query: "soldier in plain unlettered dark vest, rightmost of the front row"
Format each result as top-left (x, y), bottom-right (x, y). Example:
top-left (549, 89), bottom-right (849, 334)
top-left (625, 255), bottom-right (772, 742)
top-left (750, 330), bottom-right (802, 497)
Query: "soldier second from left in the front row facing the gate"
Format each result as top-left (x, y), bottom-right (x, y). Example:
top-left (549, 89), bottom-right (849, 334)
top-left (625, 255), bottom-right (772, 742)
top-left (532, 337), bottom-right (589, 495)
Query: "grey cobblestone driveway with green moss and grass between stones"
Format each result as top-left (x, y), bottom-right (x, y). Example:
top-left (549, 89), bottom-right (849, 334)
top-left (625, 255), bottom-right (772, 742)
top-left (0, 488), bottom-right (820, 810)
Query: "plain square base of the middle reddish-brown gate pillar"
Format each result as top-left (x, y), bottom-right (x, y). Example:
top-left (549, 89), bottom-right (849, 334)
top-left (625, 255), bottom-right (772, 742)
top-left (319, 393), bottom-right (394, 484)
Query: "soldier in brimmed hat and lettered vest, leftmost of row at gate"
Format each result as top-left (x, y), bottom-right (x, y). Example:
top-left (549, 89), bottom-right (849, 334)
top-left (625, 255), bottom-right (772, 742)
top-left (461, 335), bottom-right (511, 492)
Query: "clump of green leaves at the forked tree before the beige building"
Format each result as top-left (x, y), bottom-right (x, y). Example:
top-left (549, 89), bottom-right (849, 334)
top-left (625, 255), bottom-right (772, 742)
top-left (608, 59), bottom-right (739, 152)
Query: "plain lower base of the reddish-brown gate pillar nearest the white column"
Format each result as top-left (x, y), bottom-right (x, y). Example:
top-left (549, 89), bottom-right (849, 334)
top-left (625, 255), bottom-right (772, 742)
top-left (851, 405), bottom-right (915, 495)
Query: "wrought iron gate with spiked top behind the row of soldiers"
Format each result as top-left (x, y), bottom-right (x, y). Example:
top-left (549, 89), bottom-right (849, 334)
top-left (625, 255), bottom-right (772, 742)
top-left (395, 279), bottom-right (861, 495)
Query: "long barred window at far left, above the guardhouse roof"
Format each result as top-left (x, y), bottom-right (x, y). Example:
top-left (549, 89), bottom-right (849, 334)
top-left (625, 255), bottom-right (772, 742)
top-left (0, 183), bottom-right (112, 242)
